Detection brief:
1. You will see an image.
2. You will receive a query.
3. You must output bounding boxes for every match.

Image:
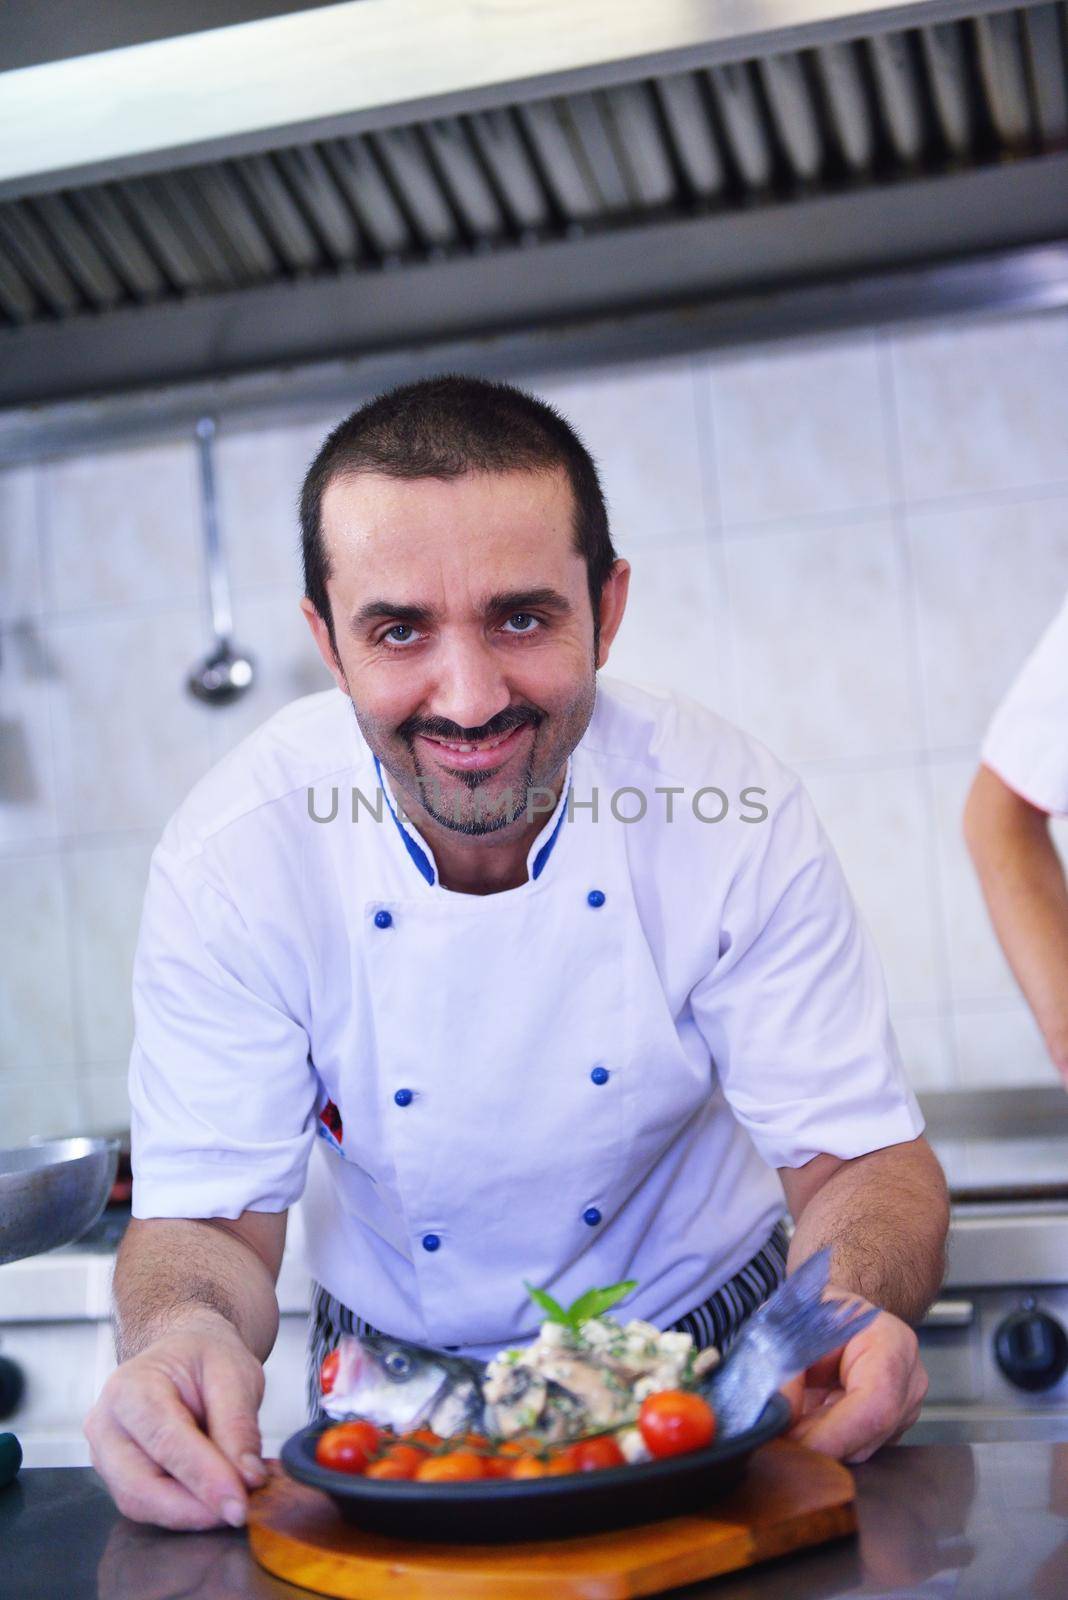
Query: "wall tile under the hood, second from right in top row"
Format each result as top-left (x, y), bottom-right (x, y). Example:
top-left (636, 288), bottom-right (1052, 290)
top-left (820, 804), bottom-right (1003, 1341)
top-left (708, 334), bottom-right (891, 526)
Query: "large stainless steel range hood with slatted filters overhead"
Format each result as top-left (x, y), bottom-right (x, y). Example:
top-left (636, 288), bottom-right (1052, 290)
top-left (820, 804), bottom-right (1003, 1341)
top-left (0, 0), bottom-right (1068, 406)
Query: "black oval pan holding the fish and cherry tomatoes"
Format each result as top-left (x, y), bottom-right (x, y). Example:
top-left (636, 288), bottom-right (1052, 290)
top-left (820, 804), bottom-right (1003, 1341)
top-left (281, 1394), bottom-right (790, 1544)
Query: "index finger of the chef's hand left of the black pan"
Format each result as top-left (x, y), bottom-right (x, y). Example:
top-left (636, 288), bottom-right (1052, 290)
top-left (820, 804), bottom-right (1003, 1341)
top-left (112, 1373), bottom-right (246, 1528)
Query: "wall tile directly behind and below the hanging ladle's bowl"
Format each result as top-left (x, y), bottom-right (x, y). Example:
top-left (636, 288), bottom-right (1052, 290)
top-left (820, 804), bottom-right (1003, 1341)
top-left (46, 606), bottom-right (213, 834)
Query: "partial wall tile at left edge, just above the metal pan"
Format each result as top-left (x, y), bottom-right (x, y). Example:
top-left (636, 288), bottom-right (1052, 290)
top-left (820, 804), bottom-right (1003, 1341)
top-left (0, 856), bottom-right (75, 1077)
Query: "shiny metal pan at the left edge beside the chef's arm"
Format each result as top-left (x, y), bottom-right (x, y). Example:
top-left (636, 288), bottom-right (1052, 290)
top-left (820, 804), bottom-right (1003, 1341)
top-left (0, 1139), bottom-right (118, 1266)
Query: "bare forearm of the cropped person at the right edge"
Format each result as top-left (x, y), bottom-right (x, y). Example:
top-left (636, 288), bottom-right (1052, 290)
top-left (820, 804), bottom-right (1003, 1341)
top-left (964, 766), bottom-right (1068, 1075)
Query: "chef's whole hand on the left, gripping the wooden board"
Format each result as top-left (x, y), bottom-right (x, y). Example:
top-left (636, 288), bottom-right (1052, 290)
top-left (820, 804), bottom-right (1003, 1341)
top-left (85, 1309), bottom-right (267, 1528)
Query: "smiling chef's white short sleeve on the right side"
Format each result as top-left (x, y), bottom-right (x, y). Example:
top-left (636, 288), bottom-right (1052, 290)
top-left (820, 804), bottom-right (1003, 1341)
top-left (691, 782), bottom-right (924, 1166)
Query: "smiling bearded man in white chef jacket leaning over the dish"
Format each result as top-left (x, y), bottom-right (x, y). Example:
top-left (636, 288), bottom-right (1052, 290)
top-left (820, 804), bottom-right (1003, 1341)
top-left (86, 376), bottom-right (946, 1528)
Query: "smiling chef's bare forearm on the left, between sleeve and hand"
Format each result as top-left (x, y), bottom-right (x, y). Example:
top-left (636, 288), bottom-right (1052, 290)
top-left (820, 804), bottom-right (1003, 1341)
top-left (114, 1218), bottom-right (278, 1362)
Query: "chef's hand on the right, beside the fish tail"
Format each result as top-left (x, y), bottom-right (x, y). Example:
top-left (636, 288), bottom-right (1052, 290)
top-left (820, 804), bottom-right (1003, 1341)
top-left (783, 1288), bottom-right (927, 1462)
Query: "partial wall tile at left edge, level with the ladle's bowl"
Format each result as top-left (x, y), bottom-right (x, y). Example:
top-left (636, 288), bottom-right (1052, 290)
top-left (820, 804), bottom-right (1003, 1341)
top-left (0, 618), bottom-right (56, 850)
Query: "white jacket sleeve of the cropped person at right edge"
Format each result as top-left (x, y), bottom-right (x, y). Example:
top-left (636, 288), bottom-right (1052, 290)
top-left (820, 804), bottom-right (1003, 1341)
top-left (982, 595), bottom-right (1068, 816)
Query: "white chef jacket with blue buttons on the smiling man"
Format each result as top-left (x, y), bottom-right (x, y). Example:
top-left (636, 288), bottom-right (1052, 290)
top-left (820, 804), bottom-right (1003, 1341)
top-left (130, 677), bottom-right (923, 1357)
